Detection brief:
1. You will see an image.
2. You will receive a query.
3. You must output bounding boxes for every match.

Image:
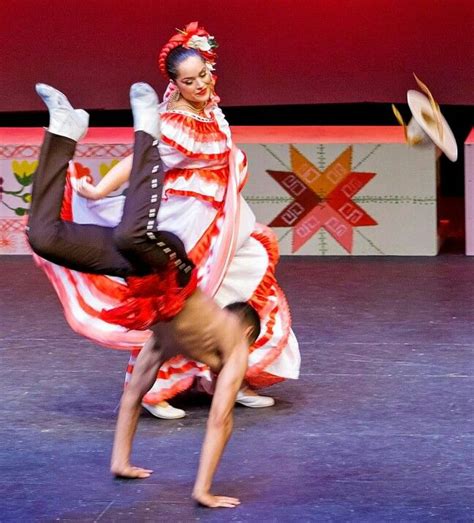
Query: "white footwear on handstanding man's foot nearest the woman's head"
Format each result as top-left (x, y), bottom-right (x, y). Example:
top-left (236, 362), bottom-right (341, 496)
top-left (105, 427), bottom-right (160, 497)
top-left (130, 82), bottom-right (160, 140)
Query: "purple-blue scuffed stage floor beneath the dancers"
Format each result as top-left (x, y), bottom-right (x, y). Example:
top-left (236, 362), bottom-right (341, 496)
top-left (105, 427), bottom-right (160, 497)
top-left (0, 254), bottom-right (474, 523)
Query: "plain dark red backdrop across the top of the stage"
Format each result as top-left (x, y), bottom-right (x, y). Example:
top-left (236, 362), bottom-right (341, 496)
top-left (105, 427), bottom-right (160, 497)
top-left (0, 0), bottom-right (474, 111)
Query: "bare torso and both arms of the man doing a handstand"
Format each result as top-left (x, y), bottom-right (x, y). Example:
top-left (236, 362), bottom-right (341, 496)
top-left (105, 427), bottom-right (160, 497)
top-left (111, 290), bottom-right (253, 508)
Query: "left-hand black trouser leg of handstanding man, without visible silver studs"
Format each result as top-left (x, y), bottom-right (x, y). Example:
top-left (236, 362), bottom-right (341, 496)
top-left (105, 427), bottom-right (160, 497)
top-left (27, 132), bottom-right (136, 276)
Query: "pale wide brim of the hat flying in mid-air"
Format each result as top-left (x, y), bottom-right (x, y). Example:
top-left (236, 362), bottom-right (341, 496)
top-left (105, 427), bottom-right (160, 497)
top-left (407, 90), bottom-right (458, 162)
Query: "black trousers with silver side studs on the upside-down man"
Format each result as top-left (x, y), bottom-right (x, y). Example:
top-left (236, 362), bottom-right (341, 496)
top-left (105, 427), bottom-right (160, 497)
top-left (27, 131), bottom-right (194, 285)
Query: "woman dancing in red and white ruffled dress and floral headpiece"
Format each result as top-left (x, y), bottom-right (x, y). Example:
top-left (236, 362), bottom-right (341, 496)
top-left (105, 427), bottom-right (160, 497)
top-left (35, 23), bottom-right (300, 417)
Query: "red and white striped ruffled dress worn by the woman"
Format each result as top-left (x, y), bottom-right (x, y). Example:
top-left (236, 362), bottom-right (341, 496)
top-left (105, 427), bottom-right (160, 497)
top-left (35, 102), bottom-right (300, 403)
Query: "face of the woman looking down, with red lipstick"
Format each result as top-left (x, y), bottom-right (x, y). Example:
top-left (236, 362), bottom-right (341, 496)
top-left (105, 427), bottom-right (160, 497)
top-left (175, 56), bottom-right (212, 104)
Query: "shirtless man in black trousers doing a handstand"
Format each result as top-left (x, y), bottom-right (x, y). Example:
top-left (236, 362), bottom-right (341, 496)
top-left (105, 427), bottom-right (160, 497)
top-left (27, 84), bottom-right (260, 508)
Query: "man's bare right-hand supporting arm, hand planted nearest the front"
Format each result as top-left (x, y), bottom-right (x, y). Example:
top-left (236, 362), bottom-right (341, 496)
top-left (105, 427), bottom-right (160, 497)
top-left (193, 339), bottom-right (248, 508)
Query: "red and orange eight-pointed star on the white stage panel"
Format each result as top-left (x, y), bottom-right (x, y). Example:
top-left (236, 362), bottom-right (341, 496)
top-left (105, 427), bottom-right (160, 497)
top-left (267, 146), bottom-right (377, 253)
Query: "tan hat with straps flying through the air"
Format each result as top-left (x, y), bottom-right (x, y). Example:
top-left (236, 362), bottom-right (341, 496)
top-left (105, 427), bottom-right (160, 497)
top-left (392, 75), bottom-right (458, 162)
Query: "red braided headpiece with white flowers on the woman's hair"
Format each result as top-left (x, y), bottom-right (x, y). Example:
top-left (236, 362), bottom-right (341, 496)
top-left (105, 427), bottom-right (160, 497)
top-left (158, 22), bottom-right (217, 78)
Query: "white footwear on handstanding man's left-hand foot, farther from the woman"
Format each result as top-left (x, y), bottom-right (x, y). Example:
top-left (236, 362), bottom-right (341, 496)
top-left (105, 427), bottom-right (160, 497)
top-left (36, 84), bottom-right (89, 142)
